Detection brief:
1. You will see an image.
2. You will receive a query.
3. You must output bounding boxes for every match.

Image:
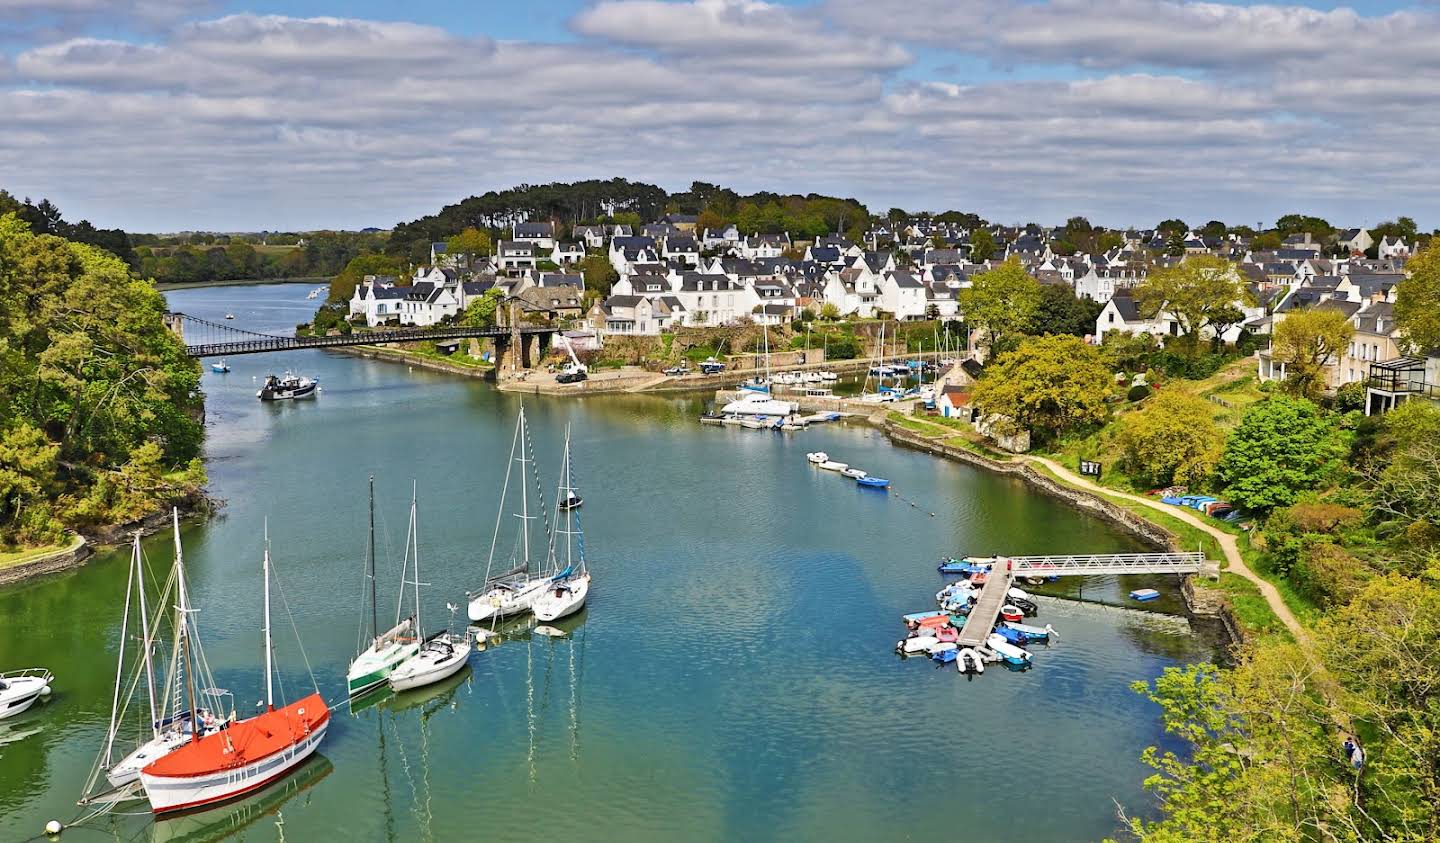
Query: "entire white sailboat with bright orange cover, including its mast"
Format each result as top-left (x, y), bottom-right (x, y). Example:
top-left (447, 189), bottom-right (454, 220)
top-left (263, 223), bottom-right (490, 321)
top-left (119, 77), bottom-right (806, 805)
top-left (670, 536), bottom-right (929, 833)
top-left (140, 521), bottom-right (330, 814)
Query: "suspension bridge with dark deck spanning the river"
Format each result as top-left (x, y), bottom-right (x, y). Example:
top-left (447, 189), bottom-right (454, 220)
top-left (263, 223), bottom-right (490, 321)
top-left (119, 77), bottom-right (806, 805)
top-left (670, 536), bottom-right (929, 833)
top-left (166, 313), bottom-right (559, 358)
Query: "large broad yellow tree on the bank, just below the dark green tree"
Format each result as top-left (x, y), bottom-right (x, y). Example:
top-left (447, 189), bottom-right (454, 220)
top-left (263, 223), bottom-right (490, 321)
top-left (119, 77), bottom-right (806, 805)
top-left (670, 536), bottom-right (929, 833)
top-left (972, 336), bottom-right (1113, 438)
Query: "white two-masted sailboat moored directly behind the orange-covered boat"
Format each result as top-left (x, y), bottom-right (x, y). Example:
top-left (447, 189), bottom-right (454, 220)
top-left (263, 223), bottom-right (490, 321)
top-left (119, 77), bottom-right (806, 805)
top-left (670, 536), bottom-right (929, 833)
top-left (81, 509), bottom-right (233, 804)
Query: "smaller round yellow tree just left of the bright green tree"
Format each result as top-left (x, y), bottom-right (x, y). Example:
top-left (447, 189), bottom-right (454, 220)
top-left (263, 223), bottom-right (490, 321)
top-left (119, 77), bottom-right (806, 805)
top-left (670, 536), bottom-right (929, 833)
top-left (1119, 389), bottom-right (1225, 486)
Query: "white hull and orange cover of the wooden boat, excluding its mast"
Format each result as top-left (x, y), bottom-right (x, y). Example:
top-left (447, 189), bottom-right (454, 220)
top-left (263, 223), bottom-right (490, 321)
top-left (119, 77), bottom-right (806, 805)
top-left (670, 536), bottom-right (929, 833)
top-left (140, 695), bottom-right (330, 814)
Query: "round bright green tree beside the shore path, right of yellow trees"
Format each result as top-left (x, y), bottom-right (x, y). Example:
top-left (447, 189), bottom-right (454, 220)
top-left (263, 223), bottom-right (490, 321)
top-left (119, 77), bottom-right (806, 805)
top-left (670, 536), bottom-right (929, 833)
top-left (1218, 395), bottom-right (1345, 512)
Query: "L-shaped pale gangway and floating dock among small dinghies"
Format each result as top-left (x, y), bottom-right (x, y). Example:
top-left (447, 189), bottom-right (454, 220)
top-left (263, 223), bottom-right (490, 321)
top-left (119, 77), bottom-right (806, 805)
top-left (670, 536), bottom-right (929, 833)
top-left (959, 552), bottom-right (1205, 647)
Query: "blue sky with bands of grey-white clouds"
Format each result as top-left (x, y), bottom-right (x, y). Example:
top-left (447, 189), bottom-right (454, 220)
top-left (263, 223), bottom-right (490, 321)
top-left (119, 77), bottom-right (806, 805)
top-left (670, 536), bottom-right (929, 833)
top-left (0, 0), bottom-right (1440, 232)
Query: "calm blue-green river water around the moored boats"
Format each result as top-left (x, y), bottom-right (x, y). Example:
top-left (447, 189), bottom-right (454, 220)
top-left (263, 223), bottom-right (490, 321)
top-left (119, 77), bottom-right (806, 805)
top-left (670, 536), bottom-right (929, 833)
top-left (0, 285), bottom-right (1208, 843)
